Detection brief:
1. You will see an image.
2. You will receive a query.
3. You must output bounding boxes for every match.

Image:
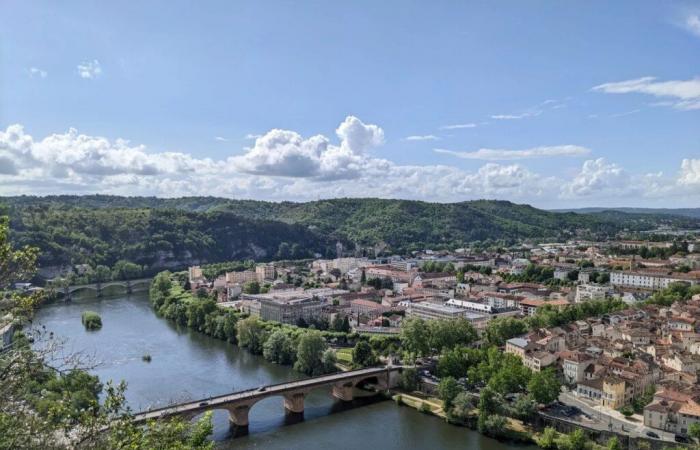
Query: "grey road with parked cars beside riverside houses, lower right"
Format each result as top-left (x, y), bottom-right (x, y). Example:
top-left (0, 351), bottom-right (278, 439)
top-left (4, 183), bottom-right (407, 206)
top-left (559, 392), bottom-right (675, 444)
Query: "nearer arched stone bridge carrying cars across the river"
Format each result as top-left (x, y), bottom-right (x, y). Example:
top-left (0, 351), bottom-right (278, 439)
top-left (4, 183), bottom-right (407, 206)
top-left (134, 366), bottom-right (402, 436)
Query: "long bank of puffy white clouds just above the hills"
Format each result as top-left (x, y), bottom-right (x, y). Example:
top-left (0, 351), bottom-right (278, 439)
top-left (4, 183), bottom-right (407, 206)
top-left (0, 117), bottom-right (700, 205)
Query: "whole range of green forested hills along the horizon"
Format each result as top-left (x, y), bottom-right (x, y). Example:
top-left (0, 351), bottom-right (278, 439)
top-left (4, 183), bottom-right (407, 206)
top-left (0, 195), bottom-right (700, 268)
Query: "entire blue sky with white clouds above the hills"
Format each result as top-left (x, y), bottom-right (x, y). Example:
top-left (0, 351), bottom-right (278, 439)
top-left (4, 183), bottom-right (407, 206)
top-left (0, 0), bottom-right (700, 208)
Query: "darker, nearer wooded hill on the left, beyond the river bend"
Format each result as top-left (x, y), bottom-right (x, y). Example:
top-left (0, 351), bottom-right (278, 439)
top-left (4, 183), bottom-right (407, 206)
top-left (12, 205), bottom-right (330, 270)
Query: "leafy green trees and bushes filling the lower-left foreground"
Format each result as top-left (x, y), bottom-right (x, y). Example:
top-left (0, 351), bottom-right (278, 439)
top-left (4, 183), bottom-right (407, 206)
top-left (0, 216), bottom-right (213, 450)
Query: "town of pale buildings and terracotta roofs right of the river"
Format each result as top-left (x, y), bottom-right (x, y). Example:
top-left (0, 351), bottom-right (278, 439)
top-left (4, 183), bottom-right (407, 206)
top-left (180, 234), bottom-right (700, 442)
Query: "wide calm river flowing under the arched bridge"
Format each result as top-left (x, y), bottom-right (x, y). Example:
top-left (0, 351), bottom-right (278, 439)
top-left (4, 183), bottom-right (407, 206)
top-left (35, 295), bottom-right (534, 450)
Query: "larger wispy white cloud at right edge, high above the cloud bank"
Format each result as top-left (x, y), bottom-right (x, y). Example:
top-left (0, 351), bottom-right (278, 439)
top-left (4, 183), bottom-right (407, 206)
top-left (592, 77), bottom-right (700, 110)
